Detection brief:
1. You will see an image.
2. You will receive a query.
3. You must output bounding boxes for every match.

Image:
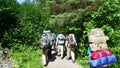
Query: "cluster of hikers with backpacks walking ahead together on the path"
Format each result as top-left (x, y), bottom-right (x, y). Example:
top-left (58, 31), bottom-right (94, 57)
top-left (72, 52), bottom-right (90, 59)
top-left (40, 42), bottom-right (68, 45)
top-left (40, 30), bottom-right (77, 66)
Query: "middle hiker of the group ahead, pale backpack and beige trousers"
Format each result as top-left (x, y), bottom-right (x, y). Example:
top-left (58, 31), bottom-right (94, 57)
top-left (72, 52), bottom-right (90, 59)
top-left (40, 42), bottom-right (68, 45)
top-left (56, 33), bottom-right (66, 59)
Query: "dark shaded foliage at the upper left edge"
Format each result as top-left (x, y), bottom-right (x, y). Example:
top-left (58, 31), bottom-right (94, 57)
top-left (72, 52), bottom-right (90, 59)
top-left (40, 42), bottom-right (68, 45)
top-left (0, 0), bottom-right (19, 41)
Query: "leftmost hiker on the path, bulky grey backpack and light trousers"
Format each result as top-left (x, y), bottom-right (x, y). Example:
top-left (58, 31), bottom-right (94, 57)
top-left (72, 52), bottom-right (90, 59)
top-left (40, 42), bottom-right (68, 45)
top-left (40, 36), bottom-right (50, 66)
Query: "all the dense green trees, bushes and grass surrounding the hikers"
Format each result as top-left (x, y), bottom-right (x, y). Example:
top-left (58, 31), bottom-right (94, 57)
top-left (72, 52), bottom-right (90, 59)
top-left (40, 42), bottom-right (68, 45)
top-left (0, 0), bottom-right (120, 68)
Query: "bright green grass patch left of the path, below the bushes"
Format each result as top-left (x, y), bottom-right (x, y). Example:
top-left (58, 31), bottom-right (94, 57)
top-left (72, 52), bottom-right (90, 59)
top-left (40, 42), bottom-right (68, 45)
top-left (10, 46), bottom-right (43, 68)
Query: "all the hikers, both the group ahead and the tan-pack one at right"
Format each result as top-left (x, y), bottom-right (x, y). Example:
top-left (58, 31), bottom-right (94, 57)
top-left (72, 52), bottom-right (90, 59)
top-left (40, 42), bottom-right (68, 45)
top-left (40, 28), bottom-right (117, 68)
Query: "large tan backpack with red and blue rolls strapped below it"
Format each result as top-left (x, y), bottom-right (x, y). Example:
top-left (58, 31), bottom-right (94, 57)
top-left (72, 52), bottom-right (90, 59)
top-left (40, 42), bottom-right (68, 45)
top-left (88, 28), bottom-right (117, 67)
